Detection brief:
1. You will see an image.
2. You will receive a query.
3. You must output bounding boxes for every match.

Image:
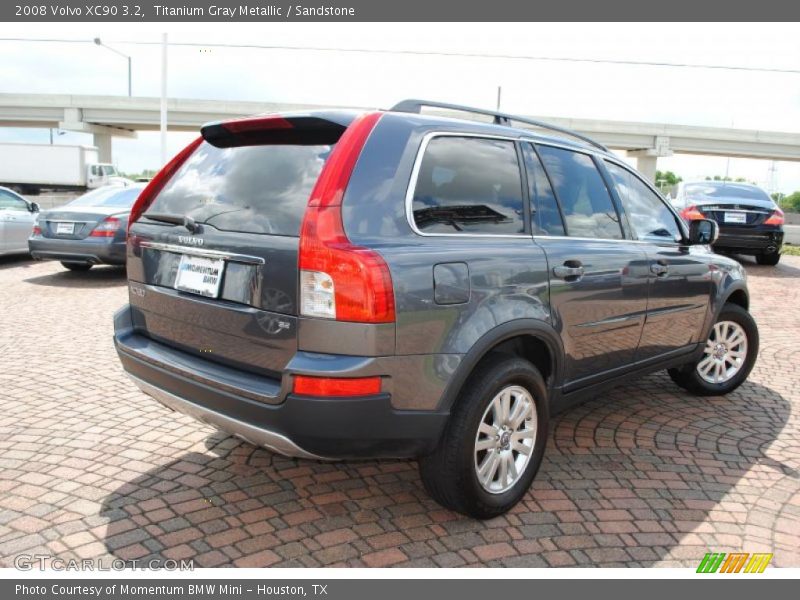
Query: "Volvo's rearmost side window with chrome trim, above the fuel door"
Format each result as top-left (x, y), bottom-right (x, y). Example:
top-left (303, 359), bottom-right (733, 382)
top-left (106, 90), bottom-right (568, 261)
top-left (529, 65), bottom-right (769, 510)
top-left (412, 136), bottom-right (525, 234)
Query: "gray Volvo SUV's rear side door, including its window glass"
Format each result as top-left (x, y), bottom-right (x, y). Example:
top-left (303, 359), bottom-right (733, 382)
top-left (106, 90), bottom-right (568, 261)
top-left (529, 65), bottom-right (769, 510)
top-left (524, 144), bottom-right (647, 391)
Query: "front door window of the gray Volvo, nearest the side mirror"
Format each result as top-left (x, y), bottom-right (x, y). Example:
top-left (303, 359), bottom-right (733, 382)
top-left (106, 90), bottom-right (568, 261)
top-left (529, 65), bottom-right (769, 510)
top-left (606, 161), bottom-right (682, 242)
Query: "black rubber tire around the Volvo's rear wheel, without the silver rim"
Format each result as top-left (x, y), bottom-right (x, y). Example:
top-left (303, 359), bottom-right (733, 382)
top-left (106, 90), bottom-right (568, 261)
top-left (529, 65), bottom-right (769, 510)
top-left (419, 355), bottom-right (548, 519)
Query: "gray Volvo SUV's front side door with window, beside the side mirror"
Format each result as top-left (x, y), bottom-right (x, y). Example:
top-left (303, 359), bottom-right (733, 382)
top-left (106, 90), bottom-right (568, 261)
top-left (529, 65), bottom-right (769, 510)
top-left (605, 161), bottom-right (711, 360)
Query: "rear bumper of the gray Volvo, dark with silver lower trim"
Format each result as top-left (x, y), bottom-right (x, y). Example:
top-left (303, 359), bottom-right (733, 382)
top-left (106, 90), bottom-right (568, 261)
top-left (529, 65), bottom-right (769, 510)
top-left (114, 307), bottom-right (448, 459)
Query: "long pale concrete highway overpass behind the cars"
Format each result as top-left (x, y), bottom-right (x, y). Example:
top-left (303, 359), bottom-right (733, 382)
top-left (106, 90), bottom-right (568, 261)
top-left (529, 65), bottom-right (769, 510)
top-left (0, 94), bottom-right (800, 179)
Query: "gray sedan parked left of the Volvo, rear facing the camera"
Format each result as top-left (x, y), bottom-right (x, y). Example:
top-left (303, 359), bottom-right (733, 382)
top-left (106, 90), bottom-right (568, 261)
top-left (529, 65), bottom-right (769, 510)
top-left (28, 184), bottom-right (144, 271)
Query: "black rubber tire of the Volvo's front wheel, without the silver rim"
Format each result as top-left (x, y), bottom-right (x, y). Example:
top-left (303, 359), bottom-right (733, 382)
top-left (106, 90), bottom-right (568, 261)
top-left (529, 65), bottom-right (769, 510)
top-left (668, 304), bottom-right (758, 396)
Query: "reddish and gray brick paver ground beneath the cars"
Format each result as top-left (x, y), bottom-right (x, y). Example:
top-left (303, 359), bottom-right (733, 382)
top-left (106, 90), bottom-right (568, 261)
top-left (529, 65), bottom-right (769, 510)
top-left (0, 257), bottom-right (800, 567)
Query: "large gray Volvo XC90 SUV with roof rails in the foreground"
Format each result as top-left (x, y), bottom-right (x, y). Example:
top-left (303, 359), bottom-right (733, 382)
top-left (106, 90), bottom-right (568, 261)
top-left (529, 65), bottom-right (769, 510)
top-left (115, 101), bottom-right (758, 518)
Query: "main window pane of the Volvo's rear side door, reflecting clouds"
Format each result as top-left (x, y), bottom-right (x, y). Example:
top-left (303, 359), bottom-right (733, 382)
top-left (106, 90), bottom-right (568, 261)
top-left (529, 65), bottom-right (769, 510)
top-left (538, 146), bottom-right (622, 239)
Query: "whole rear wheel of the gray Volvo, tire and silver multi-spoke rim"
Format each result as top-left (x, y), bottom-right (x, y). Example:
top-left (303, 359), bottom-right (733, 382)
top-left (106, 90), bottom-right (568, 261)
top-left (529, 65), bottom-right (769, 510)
top-left (420, 357), bottom-right (548, 519)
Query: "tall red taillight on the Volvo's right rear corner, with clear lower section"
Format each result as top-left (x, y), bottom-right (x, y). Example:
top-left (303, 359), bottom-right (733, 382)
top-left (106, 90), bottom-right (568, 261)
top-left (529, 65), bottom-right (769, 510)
top-left (299, 113), bottom-right (395, 323)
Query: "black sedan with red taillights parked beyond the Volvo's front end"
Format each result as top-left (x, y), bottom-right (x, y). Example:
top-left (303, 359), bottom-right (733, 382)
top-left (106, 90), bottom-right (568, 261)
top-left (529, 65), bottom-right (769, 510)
top-left (673, 181), bottom-right (784, 265)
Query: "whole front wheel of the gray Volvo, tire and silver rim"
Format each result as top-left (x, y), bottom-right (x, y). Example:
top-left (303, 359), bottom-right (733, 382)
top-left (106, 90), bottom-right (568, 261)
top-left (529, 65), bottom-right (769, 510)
top-left (669, 304), bottom-right (758, 396)
